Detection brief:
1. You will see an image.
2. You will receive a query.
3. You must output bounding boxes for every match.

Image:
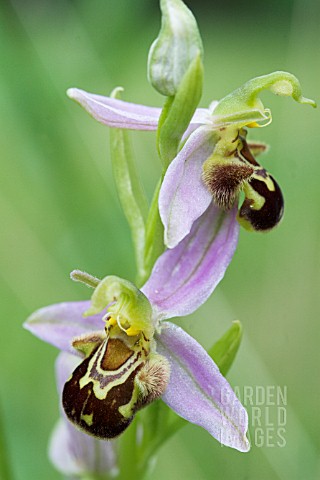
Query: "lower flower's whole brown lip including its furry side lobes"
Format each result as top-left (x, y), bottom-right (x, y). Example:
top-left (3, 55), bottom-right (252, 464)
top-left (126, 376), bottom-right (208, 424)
top-left (62, 327), bottom-right (169, 439)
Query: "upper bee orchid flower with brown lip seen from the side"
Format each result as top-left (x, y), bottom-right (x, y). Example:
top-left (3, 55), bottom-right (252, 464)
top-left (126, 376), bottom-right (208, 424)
top-left (68, 72), bottom-right (315, 248)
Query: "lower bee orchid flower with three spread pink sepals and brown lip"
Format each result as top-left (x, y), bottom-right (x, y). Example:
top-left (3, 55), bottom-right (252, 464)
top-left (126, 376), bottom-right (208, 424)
top-left (25, 207), bottom-right (249, 451)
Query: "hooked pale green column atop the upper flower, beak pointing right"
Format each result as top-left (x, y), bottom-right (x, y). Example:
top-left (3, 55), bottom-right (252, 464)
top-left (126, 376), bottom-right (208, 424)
top-left (213, 71), bottom-right (316, 126)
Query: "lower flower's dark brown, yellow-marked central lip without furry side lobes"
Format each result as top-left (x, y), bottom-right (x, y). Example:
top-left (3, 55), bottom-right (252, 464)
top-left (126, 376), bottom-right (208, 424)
top-left (62, 339), bottom-right (143, 438)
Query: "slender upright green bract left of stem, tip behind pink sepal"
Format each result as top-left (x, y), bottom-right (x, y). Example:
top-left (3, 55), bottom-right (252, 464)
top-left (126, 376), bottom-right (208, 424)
top-left (110, 88), bottom-right (148, 282)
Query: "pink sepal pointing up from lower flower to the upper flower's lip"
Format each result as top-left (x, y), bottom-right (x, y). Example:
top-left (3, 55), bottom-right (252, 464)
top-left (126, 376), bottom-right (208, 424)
top-left (142, 204), bottom-right (239, 318)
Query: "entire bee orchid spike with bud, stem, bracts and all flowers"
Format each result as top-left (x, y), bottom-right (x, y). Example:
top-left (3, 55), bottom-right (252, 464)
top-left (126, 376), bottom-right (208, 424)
top-left (25, 0), bottom-right (314, 480)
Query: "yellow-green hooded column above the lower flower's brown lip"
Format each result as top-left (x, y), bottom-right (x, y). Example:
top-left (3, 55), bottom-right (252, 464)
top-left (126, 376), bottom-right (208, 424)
top-left (84, 275), bottom-right (153, 338)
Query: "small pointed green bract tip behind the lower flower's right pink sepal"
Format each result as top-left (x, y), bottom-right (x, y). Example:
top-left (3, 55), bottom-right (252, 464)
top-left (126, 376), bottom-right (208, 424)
top-left (208, 320), bottom-right (242, 376)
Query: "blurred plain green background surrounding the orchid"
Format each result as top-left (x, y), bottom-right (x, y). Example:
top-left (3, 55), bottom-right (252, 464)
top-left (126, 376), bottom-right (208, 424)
top-left (0, 0), bottom-right (320, 480)
